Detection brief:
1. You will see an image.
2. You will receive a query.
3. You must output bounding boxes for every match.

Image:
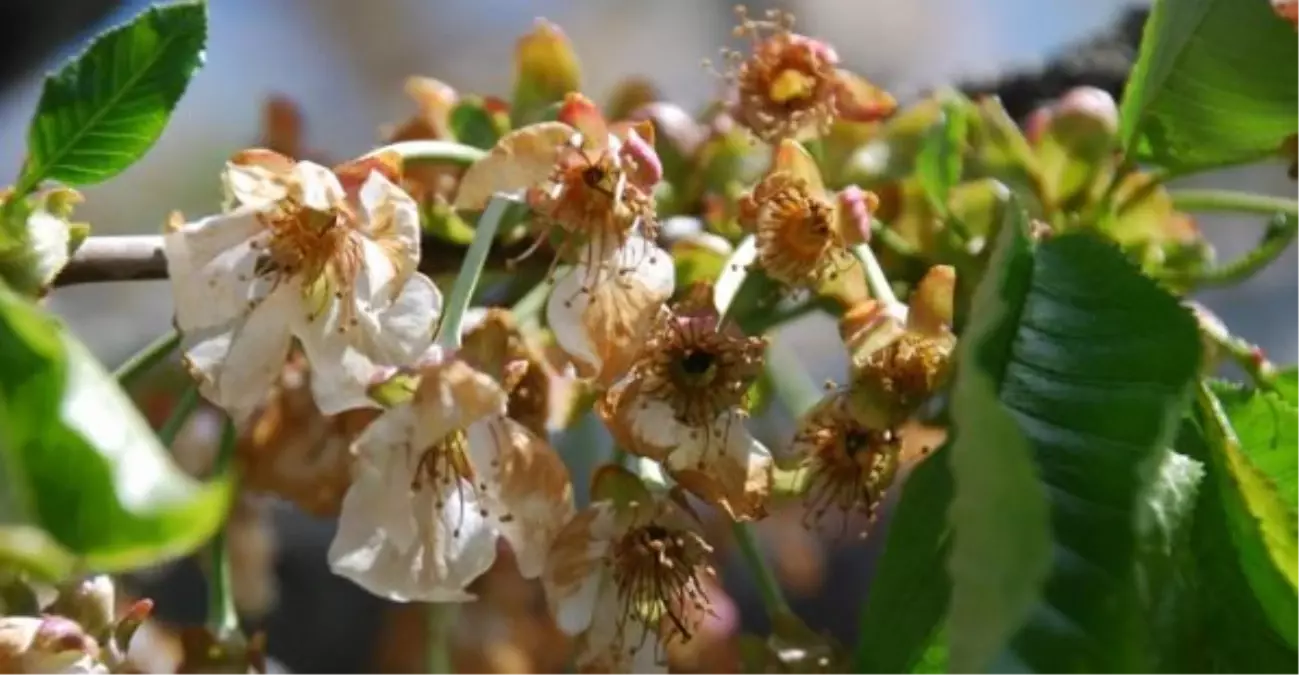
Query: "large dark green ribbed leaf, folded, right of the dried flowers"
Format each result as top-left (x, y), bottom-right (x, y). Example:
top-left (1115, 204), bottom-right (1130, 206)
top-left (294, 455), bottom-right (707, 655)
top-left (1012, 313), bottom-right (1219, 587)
top-left (948, 206), bottom-right (1199, 674)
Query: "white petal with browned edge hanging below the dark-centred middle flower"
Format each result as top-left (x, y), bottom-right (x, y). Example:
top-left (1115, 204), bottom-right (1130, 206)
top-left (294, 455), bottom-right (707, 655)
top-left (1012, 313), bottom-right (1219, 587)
top-left (668, 413), bottom-right (773, 521)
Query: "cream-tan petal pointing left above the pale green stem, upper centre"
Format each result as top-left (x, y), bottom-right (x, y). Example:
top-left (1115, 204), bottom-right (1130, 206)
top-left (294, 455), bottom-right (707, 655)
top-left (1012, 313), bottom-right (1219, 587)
top-left (455, 122), bottom-right (573, 210)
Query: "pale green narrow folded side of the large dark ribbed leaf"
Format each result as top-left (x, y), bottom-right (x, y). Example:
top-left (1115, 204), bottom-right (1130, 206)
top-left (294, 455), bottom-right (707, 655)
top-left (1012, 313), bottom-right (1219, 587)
top-left (947, 204), bottom-right (1052, 674)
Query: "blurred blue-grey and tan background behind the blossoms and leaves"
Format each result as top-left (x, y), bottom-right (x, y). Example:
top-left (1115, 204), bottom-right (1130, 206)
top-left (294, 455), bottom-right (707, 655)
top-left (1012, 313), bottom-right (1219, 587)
top-left (0, 0), bottom-right (1299, 674)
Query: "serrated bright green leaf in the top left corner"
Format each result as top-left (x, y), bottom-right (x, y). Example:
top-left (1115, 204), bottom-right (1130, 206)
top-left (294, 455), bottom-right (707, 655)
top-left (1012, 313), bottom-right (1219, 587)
top-left (18, 3), bottom-right (208, 192)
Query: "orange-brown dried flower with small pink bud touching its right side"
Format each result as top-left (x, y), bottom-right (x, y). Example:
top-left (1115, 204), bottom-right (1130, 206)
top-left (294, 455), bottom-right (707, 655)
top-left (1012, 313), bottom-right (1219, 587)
top-left (739, 140), bottom-right (878, 293)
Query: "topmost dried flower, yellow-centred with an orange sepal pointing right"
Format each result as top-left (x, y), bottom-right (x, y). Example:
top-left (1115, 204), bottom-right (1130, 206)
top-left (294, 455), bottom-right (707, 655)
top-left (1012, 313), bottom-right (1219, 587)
top-left (725, 6), bottom-right (898, 143)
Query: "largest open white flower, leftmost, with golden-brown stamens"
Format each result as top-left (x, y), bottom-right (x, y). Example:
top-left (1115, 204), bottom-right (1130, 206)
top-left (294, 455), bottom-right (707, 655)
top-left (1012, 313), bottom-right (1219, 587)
top-left (165, 151), bottom-right (442, 415)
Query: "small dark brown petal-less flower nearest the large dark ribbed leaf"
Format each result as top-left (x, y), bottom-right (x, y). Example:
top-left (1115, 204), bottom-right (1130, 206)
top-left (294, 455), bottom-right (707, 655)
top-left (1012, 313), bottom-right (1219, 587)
top-left (792, 389), bottom-right (902, 536)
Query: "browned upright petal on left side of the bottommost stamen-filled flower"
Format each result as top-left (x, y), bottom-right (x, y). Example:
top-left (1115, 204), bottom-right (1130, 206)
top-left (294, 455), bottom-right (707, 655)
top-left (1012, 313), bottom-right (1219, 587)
top-left (542, 501), bottom-right (616, 635)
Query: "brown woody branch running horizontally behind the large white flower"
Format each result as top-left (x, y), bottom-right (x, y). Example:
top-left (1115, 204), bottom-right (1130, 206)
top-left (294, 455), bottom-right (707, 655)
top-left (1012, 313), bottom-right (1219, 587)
top-left (55, 235), bottom-right (551, 288)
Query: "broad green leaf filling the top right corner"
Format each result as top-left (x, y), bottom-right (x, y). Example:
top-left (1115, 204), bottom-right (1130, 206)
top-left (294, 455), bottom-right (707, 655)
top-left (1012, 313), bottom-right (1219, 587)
top-left (1120, 0), bottom-right (1299, 170)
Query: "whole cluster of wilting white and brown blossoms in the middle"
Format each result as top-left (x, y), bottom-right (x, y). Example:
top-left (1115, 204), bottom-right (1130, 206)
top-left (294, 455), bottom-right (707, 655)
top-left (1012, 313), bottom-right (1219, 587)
top-left (147, 9), bottom-right (952, 672)
